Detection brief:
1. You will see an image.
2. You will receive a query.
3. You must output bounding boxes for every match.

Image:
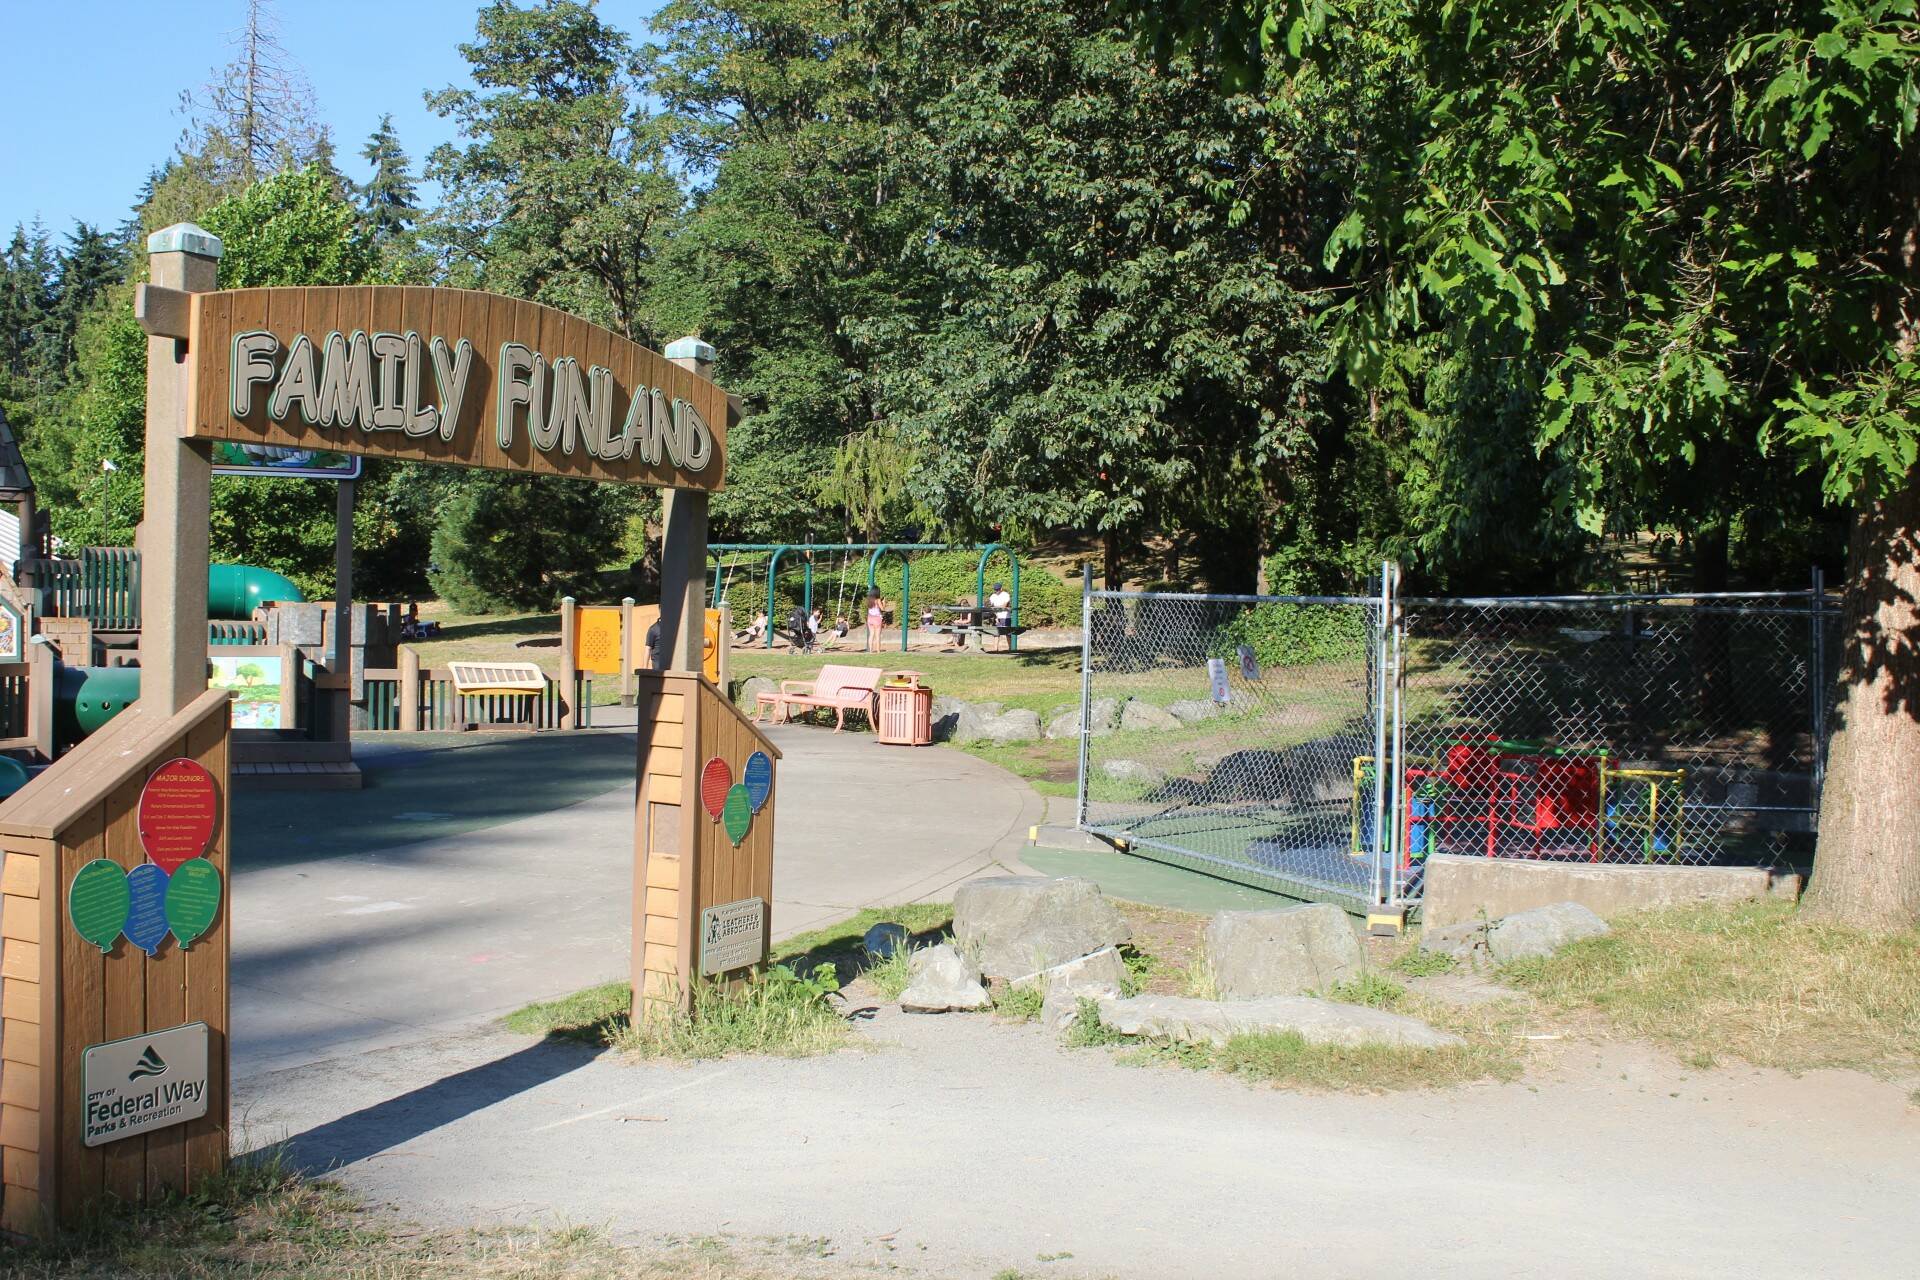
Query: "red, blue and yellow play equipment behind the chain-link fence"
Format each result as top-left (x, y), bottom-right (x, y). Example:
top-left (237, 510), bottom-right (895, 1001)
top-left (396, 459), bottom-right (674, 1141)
top-left (1348, 735), bottom-right (1686, 873)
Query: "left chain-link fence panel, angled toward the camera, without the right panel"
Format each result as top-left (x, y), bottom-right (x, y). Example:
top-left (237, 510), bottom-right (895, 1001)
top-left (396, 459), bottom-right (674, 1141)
top-left (1079, 591), bottom-right (1384, 908)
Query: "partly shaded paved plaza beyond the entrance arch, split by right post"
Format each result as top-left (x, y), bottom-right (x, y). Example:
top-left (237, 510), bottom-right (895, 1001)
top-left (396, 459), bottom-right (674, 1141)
top-left (232, 727), bottom-right (1041, 1080)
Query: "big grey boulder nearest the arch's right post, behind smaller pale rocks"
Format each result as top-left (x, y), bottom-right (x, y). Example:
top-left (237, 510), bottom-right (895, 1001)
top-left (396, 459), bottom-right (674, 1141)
top-left (954, 875), bottom-right (1133, 979)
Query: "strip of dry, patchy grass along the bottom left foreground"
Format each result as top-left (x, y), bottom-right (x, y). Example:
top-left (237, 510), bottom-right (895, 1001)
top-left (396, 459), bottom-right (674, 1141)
top-left (0, 1157), bottom-right (890, 1280)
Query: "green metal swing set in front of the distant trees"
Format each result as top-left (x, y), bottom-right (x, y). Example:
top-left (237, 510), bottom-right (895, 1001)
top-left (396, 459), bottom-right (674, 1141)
top-left (707, 543), bottom-right (1025, 652)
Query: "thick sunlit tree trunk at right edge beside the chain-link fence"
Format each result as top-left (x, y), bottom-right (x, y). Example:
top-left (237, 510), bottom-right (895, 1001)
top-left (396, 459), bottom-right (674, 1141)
top-left (1805, 472), bottom-right (1920, 929)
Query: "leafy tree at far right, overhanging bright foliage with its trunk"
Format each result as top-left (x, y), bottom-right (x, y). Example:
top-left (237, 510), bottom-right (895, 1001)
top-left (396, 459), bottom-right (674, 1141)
top-left (1129, 0), bottom-right (1920, 927)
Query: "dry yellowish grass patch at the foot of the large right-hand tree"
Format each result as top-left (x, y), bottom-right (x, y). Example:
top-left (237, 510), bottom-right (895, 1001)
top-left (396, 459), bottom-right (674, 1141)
top-left (1503, 902), bottom-right (1920, 1075)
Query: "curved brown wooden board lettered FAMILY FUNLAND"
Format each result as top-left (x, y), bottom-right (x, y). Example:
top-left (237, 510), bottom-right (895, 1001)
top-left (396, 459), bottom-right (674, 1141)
top-left (186, 286), bottom-right (733, 491)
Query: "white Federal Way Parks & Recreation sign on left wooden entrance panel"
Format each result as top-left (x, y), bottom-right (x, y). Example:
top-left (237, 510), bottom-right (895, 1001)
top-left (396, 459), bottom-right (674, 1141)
top-left (81, 1023), bottom-right (207, 1148)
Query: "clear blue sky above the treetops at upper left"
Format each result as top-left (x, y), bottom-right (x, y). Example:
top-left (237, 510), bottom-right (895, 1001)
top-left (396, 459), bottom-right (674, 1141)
top-left (0, 0), bottom-right (659, 238)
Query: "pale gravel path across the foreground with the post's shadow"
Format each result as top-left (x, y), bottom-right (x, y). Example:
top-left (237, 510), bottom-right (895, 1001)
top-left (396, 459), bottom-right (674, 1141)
top-left (240, 1009), bottom-right (1920, 1280)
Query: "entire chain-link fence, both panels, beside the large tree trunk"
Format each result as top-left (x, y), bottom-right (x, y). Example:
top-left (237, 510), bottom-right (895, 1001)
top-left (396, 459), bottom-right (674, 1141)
top-left (1079, 566), bottom-right (1839, 910)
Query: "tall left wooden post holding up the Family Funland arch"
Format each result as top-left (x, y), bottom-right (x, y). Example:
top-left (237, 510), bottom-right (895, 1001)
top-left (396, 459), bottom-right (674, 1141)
top-left (136, 223), bottom-right (221, 714)
